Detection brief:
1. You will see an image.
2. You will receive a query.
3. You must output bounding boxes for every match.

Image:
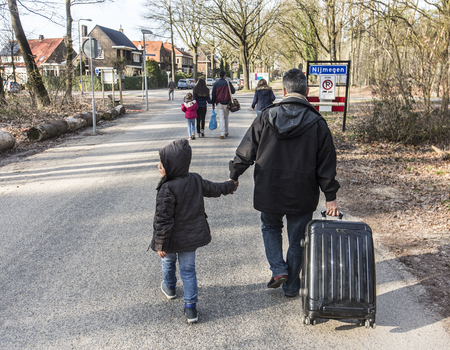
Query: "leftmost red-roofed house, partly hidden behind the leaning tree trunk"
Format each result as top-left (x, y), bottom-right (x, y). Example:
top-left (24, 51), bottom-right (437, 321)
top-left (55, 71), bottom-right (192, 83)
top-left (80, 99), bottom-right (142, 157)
top-left (0, 35), bottom-right (66, 84)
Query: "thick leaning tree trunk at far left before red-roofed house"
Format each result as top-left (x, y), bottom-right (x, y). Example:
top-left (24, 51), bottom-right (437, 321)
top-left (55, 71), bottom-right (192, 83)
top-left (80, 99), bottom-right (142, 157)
top-left (8, 0), bottom-right (50, 108)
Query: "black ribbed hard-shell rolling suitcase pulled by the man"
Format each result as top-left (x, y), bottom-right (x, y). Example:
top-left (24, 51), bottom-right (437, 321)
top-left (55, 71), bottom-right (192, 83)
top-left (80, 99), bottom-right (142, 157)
top-left (300, 211), bottom-right (376, 328)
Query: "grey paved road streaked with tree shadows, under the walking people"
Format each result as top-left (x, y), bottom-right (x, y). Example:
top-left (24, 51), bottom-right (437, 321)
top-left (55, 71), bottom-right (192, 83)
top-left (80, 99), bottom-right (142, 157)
top-left (0, 90), bottom-right (450, 350)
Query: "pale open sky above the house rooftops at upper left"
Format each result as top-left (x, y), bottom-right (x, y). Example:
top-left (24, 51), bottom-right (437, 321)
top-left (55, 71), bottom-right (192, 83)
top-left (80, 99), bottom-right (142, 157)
top-left (13, 0), bottom-right (169, 51)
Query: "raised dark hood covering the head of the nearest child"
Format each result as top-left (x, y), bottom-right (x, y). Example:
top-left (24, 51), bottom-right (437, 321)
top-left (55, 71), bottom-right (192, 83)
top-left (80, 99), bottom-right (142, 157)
top-left (159, 139), bottom-right (192, 180)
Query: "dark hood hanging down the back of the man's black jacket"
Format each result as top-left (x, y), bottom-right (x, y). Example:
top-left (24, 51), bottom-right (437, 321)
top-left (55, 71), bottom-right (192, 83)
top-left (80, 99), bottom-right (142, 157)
top-left (268, 97), bottom-right (322, 138)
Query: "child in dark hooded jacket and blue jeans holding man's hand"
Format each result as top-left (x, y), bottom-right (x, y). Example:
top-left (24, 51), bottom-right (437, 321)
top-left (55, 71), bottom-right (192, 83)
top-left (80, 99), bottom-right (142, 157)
top-left (150, 139), bottom-right (235, 323)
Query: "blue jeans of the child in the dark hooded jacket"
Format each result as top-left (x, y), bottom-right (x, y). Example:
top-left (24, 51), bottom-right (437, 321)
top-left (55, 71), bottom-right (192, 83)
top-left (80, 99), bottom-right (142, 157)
top-left (161, 250), bottom-right (198, 304)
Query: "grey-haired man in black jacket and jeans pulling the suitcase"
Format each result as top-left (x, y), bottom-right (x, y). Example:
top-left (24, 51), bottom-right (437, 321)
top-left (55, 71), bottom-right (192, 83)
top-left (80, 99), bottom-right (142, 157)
top-left (230, 69), bottom-right (340, 297)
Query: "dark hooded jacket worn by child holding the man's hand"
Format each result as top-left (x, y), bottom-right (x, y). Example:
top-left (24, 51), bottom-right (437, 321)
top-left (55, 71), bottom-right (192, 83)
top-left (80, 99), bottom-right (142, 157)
top-left (151, 139), bottom-right (234, 253)
